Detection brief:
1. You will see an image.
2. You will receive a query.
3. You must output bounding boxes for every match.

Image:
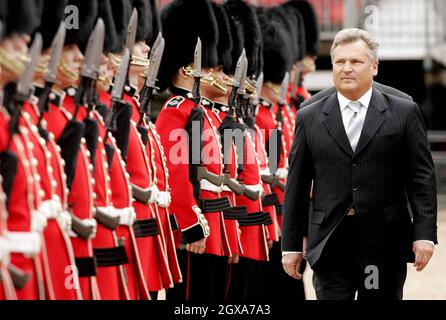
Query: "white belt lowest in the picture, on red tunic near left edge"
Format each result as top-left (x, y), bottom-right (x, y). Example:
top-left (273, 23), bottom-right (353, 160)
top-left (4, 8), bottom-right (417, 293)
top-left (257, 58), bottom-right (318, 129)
top-left (5, 231), bottom-right (42, 256)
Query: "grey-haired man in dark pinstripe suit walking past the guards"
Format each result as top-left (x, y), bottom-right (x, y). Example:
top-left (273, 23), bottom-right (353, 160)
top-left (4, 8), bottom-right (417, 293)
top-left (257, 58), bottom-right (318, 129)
top-left (282, 29), bottom-right (437, 300)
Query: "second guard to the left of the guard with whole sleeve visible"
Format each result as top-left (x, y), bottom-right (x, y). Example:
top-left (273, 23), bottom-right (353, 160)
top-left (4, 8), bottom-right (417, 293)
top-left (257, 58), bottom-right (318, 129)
top-left (107, 0), bottom-right (172, 299)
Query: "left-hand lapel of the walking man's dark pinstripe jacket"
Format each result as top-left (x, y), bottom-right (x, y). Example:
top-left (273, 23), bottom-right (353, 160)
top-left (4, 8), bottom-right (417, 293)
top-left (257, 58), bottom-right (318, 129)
top-left (322, 92), bottom-right (353, 155)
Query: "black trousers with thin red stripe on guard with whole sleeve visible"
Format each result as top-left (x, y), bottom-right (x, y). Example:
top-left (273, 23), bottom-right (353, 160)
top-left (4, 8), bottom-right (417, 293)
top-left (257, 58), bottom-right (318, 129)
top-left (166, 250), bottom-right (228, 302)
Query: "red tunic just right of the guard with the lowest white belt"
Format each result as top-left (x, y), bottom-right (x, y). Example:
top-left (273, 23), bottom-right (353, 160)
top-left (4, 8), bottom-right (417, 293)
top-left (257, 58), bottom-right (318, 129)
top-left (22, 103), bottom-right (81, 300)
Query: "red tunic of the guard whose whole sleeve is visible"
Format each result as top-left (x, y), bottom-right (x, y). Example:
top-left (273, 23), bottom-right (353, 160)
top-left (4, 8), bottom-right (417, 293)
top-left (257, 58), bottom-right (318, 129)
top-left (156, 92), bottom-right (229, 256)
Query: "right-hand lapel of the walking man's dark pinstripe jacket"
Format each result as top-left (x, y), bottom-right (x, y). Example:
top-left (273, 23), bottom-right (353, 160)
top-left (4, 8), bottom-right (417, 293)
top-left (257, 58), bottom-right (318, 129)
top-left (355, 89), bottom-right (387, 155)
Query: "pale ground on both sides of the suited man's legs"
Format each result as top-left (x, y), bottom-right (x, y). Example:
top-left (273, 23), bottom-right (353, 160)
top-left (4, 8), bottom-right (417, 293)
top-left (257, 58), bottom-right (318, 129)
top-left (304, 210), bottom-right (446, 300)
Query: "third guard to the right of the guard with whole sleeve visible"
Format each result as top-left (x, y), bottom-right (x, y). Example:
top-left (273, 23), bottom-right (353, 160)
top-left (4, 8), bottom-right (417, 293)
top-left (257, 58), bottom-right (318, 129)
top-left (256, 9), bottom-right (304, 300)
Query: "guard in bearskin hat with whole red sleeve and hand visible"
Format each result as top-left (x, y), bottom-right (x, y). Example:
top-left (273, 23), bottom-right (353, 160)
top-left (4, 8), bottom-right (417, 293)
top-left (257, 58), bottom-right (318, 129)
top-left (156, 0), bottom-right (235, 301)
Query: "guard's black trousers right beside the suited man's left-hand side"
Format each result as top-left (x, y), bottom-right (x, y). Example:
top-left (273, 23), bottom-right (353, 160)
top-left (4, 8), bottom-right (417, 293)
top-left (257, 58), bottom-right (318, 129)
top-left (262, 241), bottom-right (307, 301)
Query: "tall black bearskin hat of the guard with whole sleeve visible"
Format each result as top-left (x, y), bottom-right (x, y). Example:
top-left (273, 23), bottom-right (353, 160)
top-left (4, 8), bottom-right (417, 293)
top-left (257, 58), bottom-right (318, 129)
top-left (158, 0), bottom-right (219, 91)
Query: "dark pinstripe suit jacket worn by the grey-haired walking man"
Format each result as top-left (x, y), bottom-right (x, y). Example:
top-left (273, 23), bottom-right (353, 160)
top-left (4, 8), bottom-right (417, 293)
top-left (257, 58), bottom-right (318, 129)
top-left (282, 89), bottom-right (437, 266)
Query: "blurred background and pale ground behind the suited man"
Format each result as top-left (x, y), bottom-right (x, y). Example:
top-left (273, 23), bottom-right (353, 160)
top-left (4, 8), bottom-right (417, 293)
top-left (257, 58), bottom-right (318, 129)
top-left (154, 0), bottom-right (446, 299)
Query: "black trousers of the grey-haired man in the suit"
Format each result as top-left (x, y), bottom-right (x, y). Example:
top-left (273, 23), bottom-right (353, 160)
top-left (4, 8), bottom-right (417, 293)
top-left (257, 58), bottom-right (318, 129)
top-left (313, 217), bottom-right (407, 300)
